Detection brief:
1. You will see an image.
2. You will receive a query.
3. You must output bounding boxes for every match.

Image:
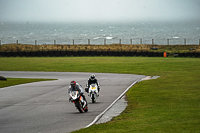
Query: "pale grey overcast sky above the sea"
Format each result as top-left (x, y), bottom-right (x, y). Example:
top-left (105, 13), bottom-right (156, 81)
top-left (0, 0), bottom-right (200, 22)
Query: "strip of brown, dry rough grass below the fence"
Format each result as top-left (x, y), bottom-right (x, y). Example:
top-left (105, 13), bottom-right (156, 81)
top-left (0, 44), bottom-right (200, 53)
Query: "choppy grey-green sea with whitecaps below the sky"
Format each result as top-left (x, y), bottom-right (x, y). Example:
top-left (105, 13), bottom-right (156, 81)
top-left (0, 21), bottom-right (200, 45)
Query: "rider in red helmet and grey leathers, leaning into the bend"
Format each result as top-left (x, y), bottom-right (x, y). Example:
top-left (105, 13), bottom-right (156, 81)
top-left (68, 80), bottom-right (87, 105)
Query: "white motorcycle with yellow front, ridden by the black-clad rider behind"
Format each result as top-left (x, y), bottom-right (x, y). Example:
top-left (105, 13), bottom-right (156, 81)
top-left (88, 84), bottom-right (99, 103)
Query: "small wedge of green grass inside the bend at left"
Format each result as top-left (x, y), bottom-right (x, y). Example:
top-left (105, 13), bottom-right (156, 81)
top-left (0, 78), bottom-right (54, 88)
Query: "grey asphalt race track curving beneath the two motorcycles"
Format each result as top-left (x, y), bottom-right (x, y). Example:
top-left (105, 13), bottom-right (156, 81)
top-left (0, 71), bottom-right (145, 133)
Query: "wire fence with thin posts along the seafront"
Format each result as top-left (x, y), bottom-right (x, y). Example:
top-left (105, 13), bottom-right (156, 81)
top-left (0, 38), bottom-right (200, 45)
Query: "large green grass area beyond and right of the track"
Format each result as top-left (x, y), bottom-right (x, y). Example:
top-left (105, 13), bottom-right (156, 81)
top-left (0, 57), bottom-right (200, 133)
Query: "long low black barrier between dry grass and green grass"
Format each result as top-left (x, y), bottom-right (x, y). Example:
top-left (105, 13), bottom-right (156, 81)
top-left (0, 51), bottom-right (200, 58)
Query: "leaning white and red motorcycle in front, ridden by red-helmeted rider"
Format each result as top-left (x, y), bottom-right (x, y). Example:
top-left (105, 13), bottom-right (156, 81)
top-left (69, 91), bottom-right (88, 113)
